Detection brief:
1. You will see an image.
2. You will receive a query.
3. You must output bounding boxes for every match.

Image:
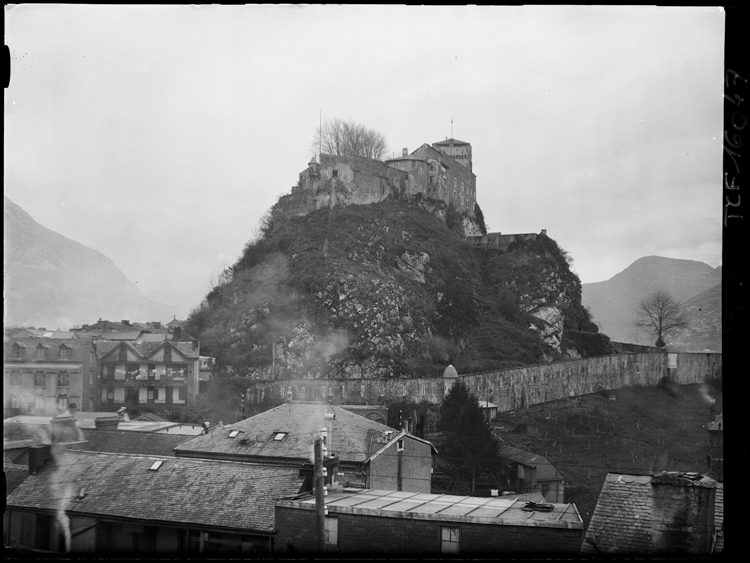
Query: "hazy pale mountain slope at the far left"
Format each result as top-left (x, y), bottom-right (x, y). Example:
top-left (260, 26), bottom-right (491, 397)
top-left (3, 197), bottom-right (173, 329)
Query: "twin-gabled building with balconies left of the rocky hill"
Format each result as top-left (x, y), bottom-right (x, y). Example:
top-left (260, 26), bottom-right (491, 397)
top-left (94, 340), bottom-right (200, 412)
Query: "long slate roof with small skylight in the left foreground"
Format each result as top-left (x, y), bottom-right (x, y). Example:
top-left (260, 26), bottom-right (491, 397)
top-left (7, 450), bottom-right (302, 533)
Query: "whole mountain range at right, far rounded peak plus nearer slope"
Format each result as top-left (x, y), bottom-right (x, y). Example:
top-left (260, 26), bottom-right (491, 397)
top-left (582, 256), bottom-right (721, 351)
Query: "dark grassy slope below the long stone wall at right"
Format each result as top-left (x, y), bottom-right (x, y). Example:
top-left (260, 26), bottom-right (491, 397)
top-left (493, 385), bottom-right (722, 528)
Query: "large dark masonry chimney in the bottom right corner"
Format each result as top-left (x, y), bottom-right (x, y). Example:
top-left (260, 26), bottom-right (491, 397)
top-left (651, 471), bottom-right (716, 554)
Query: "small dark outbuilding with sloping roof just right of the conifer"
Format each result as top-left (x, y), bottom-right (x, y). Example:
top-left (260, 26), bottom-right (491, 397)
top-left (500, 446), bottom-right (565, 502)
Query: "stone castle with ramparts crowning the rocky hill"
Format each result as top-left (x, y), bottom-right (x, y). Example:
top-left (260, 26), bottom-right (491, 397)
top-left (292, 139), bottom-right (477, 219)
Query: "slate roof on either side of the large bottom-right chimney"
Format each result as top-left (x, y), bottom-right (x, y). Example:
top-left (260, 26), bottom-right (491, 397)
top-left (581, 473), bottom-right (724, 554)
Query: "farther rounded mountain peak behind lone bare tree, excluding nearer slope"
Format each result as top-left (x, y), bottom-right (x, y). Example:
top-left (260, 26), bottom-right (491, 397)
top-left (582, 256), bottom-right (721, 344)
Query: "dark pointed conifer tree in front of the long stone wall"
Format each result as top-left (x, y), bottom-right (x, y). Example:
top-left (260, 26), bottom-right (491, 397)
top-left (438, 381), bottom-right (505, 494)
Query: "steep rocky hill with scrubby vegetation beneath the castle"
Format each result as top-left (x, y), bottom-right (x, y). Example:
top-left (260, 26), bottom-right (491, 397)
top-left (187, 198), bottom-right (609, 378)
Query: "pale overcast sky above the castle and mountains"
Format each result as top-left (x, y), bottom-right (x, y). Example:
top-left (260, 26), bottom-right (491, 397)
top-left (4, 5), bottom-right (725, 315)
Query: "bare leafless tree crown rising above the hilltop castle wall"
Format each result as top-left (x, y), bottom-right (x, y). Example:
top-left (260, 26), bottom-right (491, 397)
top-left (311, 119), bottom-right (388, 160)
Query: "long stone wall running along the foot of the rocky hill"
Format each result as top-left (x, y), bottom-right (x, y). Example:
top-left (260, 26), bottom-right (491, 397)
top-left (247, 352), bottom-right (722, 412)
